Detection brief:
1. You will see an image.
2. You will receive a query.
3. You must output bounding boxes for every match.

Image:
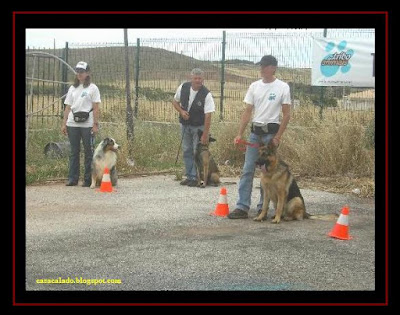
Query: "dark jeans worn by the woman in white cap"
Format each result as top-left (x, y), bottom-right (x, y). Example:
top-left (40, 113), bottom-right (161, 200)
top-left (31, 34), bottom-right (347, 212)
top-left (67, 126), bottom-right (93, 183)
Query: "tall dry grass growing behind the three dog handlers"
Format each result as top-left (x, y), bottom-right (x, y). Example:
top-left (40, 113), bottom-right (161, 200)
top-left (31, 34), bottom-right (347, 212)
top-left (26, 102), bottom-right (375, 197)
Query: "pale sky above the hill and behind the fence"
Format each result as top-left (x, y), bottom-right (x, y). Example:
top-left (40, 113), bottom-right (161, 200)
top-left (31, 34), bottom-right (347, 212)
top-left (26, 28), bottom-right (374, 68)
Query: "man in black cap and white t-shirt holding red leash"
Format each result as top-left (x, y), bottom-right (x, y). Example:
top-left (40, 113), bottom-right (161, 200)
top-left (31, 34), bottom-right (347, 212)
top-left (228, 55), bottom-right (291, 219)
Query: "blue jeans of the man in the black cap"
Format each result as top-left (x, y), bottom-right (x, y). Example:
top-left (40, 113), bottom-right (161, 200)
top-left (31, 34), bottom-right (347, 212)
top-left (236, 133), bottom-right (275, 212)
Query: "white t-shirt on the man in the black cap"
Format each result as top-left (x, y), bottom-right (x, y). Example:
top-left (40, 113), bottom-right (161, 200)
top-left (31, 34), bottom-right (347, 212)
top-left (244, 79), bottom-right (291, 124)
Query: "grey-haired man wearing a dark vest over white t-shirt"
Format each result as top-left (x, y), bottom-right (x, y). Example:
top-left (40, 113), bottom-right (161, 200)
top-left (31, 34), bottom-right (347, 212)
top-left (172, 68), bottom-right (215, 187)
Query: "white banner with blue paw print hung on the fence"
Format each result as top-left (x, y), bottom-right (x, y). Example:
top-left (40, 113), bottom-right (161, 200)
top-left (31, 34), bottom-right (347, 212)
top-left (311, 38), bottom-right (375, 87)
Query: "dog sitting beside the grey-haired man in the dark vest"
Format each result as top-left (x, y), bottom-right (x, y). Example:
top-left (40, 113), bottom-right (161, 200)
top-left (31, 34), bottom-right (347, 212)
top-left (194, 130), bottom-right (220, 188)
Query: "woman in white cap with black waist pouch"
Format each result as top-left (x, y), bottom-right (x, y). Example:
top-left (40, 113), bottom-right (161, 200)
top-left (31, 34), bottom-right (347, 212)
top-left (61, 61), bottom-right (101, 187)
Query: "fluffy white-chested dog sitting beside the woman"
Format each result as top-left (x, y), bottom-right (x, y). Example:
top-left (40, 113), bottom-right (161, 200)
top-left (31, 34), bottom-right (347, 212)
top-left (90, 138), bottom-right (120, 188)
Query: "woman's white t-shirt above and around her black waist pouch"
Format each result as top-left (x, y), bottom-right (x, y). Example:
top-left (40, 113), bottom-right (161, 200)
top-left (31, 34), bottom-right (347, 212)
top-left (64, 83), bottom-right (101, 127)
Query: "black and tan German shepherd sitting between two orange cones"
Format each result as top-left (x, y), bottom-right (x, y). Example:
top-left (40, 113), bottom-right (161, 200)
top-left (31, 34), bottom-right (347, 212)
top-left (254, 142), bottom-right (310, 223)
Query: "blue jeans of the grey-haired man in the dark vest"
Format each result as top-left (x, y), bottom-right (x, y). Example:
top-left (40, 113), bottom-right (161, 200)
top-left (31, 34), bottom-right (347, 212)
top-left (181, 124), bottom-right (204, 180)
